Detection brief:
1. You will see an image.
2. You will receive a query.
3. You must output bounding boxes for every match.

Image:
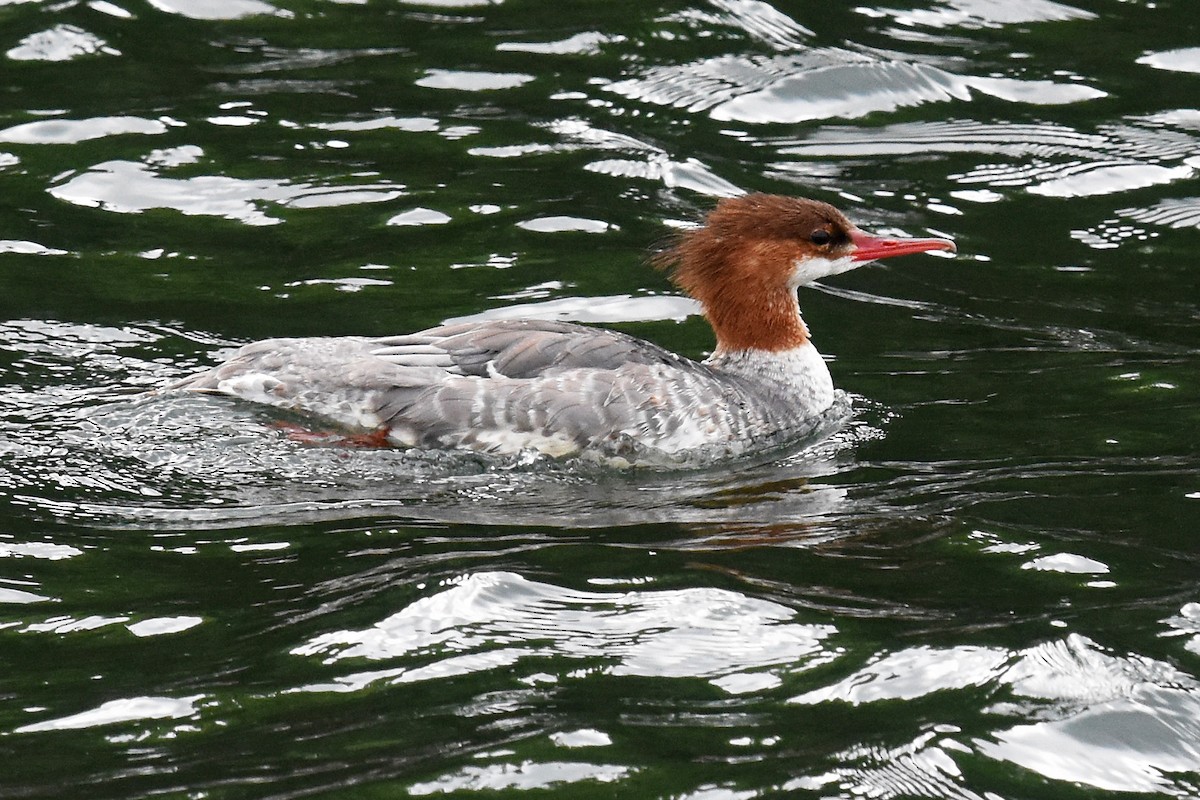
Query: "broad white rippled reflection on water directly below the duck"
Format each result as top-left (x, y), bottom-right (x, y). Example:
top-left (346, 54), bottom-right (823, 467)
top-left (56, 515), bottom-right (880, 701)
top-left (292, 572), bottom-right (835, 691)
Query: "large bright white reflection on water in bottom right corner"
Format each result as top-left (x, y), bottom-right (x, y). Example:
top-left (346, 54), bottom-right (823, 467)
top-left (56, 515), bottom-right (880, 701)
top-left (793, 633), bottom-right (1200, 798)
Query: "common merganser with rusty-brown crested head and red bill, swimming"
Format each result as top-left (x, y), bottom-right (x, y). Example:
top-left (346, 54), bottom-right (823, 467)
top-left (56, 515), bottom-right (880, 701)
top-left (175, 194), bottom-right (955, 463)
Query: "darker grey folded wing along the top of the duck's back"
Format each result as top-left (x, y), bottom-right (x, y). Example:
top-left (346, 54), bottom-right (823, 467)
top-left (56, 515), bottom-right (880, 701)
top-left (373, 320), bottom-right (694, 378)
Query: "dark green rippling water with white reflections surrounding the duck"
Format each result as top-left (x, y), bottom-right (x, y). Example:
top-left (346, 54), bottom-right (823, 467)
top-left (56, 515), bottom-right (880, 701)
top-left (0, 0), bottom-right (1200, 800)
